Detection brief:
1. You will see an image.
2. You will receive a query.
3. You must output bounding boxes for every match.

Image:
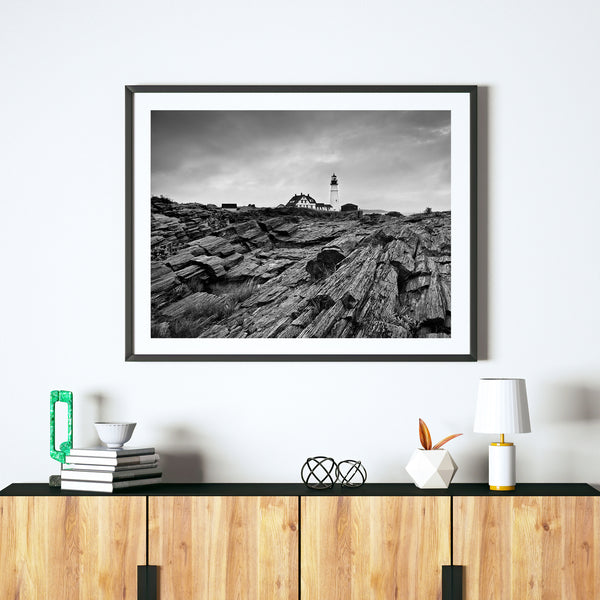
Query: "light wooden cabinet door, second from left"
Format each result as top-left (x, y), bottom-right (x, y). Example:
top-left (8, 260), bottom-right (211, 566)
top-left (148, 496), bottom-right (298, 600)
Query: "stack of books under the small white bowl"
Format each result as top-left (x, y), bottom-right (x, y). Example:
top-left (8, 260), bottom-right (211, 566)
top-left (60, 447), bottom-right (162, 492)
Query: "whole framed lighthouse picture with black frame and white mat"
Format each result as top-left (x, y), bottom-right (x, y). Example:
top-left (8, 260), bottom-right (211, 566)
top-left (125, 86), bottom-right (477, 361)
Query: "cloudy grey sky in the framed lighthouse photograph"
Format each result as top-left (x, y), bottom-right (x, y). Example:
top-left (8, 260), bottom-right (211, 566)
top-left (152, 111), bottom-right (450, 213)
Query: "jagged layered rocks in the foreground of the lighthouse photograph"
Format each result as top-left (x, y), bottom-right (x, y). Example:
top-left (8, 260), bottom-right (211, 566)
top-left (151, 198), bottom-right (451, 338)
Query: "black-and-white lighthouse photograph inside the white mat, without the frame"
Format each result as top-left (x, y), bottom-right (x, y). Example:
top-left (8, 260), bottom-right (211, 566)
top-left (124, 86), bottom-right (476, 354)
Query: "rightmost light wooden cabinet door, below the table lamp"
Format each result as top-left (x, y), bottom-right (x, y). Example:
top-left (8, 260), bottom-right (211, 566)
top-left (453, 496), bottom-right (600, 600)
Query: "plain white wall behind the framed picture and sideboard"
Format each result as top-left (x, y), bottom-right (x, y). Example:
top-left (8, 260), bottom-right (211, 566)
top-left (0, 0), bottom-right (600, 487)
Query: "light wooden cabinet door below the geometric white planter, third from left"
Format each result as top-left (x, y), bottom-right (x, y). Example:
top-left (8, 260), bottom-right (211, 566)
top-left (301, 496), bottom-right (450, 600)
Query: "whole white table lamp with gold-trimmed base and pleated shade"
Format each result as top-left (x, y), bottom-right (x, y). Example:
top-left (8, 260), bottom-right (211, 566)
top-left (473, 379), bottom-right (531, 491)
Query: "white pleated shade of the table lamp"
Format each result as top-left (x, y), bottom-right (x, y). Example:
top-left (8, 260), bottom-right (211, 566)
top-left (473, 379), bottom-right (531, 433)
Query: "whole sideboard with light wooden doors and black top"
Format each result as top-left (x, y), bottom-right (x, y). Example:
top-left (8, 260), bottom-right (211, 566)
top-left (0, 484), bottom-right (600, 600)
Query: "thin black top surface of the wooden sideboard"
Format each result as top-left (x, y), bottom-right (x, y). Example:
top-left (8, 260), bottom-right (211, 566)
top-left (0, 483), bottom-right (600, 497)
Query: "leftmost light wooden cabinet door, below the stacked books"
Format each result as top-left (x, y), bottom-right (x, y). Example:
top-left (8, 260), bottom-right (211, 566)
top-left (0, 496), bottom-right (146, 600)
